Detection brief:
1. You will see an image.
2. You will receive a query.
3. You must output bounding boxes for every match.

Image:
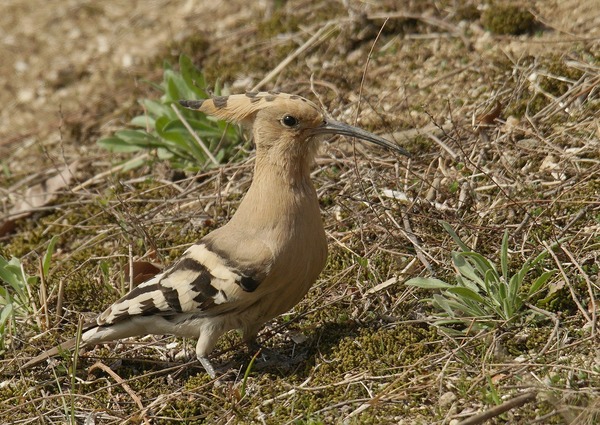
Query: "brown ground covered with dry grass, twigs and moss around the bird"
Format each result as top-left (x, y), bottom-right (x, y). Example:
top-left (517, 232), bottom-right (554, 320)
top-left (0, 0), bottom-right (600, 424)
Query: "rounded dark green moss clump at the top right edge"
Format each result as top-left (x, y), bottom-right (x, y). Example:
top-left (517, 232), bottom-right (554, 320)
top-left (481, 4), bottom-right (536, 35)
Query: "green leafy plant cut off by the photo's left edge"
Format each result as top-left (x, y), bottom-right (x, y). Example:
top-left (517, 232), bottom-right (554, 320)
top-left (0, 236), bottom-right (57, 353)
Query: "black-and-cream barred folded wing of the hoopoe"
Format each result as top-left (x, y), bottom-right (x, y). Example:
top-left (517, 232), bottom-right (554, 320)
top-left (96, 234), bottom-right (273, 326)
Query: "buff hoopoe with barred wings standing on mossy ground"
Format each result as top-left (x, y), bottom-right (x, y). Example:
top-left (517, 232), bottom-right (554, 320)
top-left (24, 92), bottom-right (408, 378)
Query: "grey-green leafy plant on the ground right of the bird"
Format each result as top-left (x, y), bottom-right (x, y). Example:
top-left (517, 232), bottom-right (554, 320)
top-left (406, 222), bottom-right (556, 332)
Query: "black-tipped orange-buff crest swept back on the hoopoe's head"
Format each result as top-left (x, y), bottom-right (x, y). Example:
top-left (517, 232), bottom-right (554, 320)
top-left (179, 91), bottom-right (320, 123)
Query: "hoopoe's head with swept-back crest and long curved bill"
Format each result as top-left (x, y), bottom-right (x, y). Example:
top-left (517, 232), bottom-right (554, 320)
top-left (180, 92), bottom-right (409, 160)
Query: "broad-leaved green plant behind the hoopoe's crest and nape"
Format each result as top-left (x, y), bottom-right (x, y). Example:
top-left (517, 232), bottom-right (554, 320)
top-left (97, 55), bottom-right (241, 171)
